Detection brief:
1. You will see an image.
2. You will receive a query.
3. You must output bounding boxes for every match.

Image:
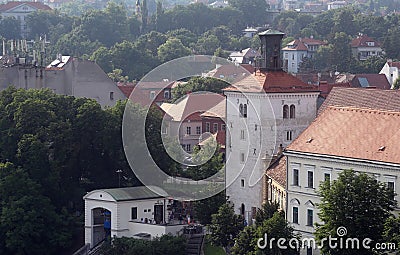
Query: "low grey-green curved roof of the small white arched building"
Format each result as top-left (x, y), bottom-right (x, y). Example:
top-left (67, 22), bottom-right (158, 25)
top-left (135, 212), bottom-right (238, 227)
top-left (84, 186), bottom-right (168, 201)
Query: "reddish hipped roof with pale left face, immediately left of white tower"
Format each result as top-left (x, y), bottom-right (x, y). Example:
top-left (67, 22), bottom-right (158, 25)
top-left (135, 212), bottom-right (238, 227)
top-left (161, 92), bottom-right (225, 121)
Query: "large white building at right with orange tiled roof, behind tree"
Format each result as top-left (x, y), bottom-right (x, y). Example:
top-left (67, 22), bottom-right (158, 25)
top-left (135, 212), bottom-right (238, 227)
top-left (285, 106), bottom-right (400, 255)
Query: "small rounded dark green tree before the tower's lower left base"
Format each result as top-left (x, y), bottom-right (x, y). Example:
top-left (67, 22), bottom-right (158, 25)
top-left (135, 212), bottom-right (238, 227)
top-left (210, 203), bottom-right (243, 249)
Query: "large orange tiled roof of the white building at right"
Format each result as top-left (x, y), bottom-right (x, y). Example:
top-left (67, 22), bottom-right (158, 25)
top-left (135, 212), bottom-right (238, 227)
top-left (287, 107), bottom-right (400, 164)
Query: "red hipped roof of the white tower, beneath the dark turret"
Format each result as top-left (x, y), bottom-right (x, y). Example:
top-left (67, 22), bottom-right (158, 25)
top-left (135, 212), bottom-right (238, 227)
top-left (224, 71), bottom-right (319, 93)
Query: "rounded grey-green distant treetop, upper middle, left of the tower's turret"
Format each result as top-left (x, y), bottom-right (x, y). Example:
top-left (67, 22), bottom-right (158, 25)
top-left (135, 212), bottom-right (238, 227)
top-left (157, 38), bottom-right (191, 63)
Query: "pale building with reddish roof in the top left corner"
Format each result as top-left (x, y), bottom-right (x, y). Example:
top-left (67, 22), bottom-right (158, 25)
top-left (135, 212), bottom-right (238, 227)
top-left (0, 1), bottom-right (51, 39)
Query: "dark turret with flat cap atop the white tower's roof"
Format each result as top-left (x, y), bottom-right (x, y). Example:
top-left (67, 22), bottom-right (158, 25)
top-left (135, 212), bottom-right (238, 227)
top-left (258, 29), bottom-right (285, 71)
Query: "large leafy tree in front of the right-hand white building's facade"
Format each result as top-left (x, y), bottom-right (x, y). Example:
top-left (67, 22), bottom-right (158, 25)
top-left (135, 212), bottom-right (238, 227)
top-left (315, 170), bottom-right (396, 254)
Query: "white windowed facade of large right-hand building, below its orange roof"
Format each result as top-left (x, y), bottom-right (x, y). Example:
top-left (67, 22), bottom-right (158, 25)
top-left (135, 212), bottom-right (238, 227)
top-left (286, 152), bottom-right (400, 254)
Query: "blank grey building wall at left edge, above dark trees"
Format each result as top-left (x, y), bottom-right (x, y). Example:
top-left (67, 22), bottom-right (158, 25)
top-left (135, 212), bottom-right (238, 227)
top-left (0, 59), bottom-right (126, 107)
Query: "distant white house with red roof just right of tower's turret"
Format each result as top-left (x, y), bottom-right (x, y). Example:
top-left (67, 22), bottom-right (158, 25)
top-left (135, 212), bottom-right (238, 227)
top-left (282, 38), bottom-right (326, 73)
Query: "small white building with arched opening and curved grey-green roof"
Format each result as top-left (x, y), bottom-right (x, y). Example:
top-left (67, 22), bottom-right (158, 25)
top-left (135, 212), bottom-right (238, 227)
top-left (83, 186), bottom-right (186, 248)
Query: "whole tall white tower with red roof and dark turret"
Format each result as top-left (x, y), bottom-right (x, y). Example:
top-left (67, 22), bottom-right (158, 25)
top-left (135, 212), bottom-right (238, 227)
top-left (224, 30), bottom-right (319, 223)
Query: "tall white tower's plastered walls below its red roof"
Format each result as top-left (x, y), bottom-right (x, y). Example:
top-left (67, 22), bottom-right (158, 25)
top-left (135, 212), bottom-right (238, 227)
top-left (226, 92), bottom-right (318, 222)
